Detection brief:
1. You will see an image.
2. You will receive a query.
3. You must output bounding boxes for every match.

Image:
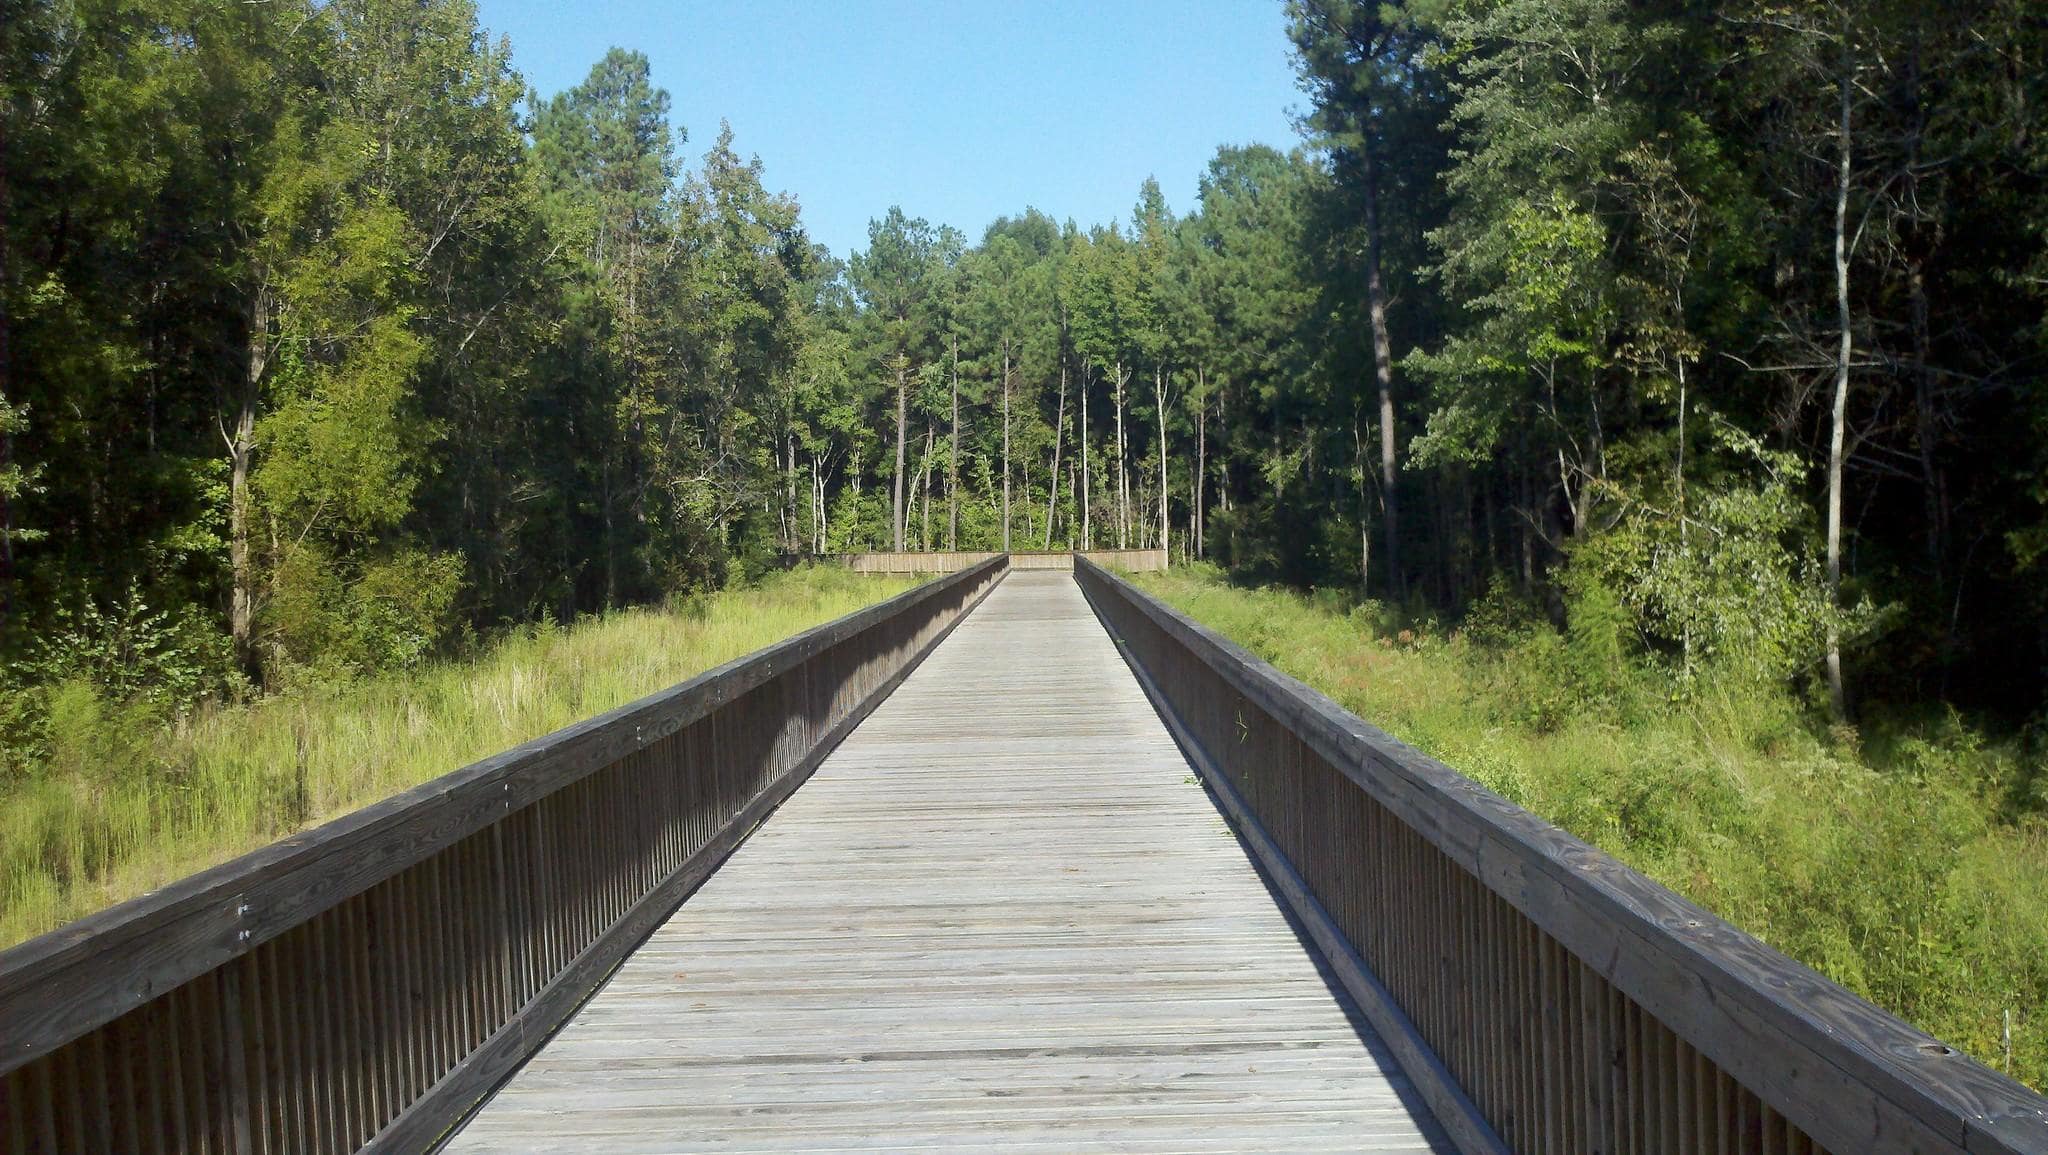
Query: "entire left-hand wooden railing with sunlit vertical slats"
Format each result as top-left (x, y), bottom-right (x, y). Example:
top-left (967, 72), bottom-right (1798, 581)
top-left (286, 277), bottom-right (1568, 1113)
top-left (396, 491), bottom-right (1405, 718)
top-left (0, 557), bottom-right (1006, 1155)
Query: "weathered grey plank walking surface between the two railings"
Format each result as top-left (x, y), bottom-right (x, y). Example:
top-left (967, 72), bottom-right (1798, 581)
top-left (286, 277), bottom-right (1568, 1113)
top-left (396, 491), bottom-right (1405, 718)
top-left (449, 573), bottom-right (1448, 1153)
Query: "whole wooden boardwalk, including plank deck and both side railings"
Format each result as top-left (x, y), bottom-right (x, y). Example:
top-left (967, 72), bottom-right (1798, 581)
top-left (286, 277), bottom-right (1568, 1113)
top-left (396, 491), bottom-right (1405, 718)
top-left (0, 555), bottom-right (2048, 1153)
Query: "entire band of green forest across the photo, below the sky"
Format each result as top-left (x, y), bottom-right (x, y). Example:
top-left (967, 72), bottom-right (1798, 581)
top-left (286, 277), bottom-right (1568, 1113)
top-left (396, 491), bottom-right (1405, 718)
top-left (0, 0), bottom-right (2048, 745)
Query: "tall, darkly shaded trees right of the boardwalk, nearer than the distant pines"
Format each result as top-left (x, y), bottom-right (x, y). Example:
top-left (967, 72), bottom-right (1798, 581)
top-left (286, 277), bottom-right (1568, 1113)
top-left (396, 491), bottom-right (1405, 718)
top-left (1278, 0), bottom-right (2048, 719)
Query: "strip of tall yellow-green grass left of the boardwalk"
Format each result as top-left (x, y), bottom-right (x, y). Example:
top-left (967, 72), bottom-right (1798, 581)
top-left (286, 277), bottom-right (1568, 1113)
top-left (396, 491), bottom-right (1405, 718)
top-left (0, 567), bottom-right (915, 946)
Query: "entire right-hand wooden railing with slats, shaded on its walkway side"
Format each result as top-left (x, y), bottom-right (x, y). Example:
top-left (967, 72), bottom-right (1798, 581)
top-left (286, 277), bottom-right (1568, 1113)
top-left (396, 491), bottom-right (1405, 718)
top-left (1075, 561), bottom-right (2048, 1155)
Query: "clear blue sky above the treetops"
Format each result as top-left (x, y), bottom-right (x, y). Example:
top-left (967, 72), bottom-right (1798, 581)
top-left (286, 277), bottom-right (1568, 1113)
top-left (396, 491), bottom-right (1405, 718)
top-left (479, 0), bottom-right (1303, 256)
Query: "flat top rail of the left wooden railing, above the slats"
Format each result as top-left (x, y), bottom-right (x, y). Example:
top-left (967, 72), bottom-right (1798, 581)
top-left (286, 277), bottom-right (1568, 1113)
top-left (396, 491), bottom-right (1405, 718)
top-left (0, 555), bottom-right (1006, 1073)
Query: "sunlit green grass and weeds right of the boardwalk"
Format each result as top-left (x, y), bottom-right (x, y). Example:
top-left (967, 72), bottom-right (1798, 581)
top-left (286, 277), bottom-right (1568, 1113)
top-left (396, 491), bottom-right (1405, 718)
top-left (1141, 569), bottom-right (2048, 1087)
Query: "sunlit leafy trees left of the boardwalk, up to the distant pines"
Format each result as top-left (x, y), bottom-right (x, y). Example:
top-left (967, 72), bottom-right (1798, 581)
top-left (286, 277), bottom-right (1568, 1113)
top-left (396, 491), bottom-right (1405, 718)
top-left (0, 0), bottom-right (829, 729)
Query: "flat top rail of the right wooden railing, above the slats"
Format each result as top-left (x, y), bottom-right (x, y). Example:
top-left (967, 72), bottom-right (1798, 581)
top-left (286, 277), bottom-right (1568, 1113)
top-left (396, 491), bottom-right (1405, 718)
top-left (1077, 557), bottom-right (2048, 1153)
